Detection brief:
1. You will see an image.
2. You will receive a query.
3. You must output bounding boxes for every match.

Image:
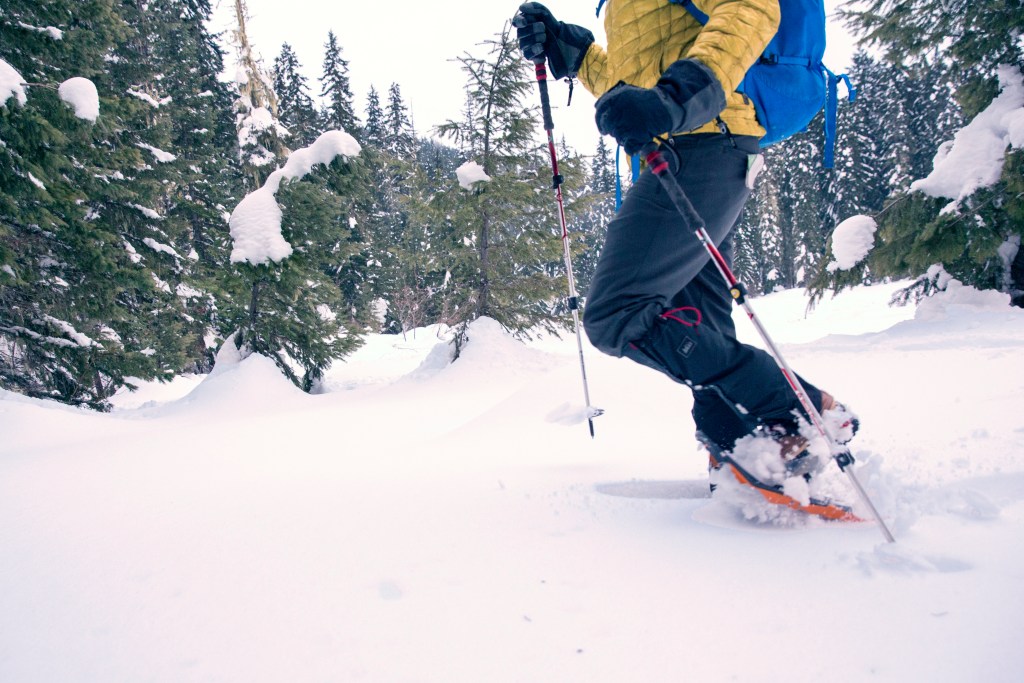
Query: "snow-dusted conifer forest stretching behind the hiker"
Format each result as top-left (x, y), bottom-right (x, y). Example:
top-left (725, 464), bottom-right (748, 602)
top-left (0, 0), bottom-right (1024, 410)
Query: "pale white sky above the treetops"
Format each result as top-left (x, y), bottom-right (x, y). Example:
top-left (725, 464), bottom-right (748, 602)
top-left (213, 0), bottom-right (853, 154)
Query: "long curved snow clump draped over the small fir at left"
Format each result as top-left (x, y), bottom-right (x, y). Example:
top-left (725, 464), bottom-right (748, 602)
top-left (228, 130), bottom-right (360, 265)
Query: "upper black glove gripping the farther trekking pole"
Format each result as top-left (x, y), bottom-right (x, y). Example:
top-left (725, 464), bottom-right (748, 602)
top-left (512, 2), bottom-right (594, 80)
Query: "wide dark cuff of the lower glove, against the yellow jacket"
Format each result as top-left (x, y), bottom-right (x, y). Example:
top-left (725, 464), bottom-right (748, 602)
top-left (654, 59), bottom-right (725, 133)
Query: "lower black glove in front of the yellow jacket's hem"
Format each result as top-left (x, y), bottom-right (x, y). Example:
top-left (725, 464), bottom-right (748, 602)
top-left (595, 59), bottom-right (725, 155)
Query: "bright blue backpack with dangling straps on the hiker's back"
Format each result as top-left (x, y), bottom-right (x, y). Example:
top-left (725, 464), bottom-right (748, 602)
top-left (597, 0), bottom-right (856, 168)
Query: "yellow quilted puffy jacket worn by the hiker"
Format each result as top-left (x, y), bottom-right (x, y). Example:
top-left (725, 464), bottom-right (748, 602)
top-left (579, 0), bottom-right (780, 137)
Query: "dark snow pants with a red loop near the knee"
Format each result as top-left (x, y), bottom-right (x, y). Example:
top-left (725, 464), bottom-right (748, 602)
top-left (584, 134), bottom-right (821, 450)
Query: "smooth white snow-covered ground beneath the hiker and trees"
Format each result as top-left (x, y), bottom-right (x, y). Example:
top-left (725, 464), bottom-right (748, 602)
top-left (0, 286), bottom-right (1024, 683)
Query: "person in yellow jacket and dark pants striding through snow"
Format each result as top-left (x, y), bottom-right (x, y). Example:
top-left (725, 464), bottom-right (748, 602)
top-left (513, 0), bottom-right (858, 491)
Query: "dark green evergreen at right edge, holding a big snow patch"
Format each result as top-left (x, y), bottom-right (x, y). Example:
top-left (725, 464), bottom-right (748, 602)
top-left (844, 0), bottom-right (1024, 305)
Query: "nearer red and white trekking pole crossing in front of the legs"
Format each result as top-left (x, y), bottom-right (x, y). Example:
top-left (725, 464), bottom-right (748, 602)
top-left (640, 143), bottom-right (896, 543)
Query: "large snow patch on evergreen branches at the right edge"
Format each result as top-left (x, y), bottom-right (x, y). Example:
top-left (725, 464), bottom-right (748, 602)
top-left (910, 66), bottom-right (1024, 213)
